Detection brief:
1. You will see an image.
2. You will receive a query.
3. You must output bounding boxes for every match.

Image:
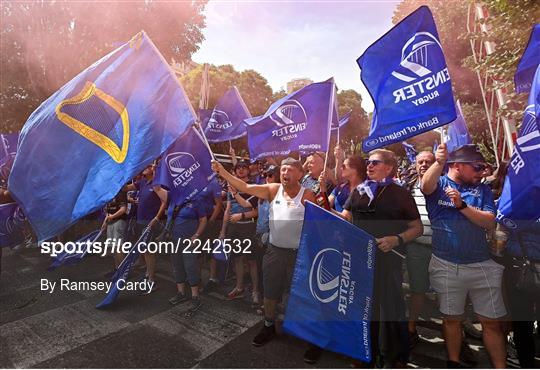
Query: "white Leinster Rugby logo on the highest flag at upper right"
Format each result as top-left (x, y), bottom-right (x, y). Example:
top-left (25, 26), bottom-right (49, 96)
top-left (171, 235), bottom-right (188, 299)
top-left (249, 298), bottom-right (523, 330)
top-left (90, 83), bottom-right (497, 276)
top-left (392, 32), bottom-right (450, 106)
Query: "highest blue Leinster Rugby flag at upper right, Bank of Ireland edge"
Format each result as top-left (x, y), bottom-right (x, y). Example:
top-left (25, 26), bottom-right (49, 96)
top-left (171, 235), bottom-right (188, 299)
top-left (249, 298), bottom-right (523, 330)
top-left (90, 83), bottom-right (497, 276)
top-left (357, 6), bottom-right (456, 152)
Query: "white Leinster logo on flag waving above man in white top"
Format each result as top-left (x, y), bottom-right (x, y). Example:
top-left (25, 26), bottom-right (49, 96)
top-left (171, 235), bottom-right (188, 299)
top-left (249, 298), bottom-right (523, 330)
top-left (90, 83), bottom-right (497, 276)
top-left (270, 99), bottom-right (307, 141)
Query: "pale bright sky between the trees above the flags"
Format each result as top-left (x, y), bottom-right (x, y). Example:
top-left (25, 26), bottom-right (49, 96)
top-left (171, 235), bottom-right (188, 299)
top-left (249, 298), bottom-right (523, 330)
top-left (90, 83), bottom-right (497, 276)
top-left (192, 0), bottom-right (400, 112)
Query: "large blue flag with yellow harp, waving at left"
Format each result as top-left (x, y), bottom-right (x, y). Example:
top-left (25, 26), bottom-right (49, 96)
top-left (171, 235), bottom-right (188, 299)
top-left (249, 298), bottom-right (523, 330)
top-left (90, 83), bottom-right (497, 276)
top-left (9, 32), bottom-right (195, 240)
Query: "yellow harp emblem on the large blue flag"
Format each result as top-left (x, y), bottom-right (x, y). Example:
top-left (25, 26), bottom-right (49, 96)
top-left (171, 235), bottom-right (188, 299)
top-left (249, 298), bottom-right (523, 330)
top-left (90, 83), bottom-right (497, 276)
top-left (56, 81), bottom-right (129, 163)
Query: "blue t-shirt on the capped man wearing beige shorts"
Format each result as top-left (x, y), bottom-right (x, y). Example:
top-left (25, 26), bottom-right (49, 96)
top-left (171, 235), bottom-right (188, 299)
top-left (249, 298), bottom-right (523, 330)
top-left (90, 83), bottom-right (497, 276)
top-left (425, 175), bottom-right (495, 264)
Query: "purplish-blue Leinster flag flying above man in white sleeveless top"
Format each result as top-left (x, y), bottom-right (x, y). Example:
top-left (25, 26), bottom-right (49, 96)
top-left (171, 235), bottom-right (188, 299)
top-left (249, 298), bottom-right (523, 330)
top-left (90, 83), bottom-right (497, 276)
top-left (245, 79), bottom-right (335, 160)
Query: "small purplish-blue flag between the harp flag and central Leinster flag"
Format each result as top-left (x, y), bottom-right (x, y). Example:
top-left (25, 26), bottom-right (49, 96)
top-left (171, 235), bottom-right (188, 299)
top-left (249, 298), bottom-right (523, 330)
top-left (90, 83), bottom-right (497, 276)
top-left (203, 86), bottom-right (251, 143)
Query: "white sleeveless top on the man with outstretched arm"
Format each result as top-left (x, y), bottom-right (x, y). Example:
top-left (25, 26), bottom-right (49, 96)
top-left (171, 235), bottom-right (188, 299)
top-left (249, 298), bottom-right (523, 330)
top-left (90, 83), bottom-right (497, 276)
top-left (270, 185), bottom-right (306, 249)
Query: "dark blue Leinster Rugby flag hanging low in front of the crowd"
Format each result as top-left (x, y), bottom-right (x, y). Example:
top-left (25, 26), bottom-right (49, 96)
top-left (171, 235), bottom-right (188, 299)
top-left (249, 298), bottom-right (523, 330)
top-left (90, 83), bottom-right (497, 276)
top-left (283, 202), bottom-right (377, 362)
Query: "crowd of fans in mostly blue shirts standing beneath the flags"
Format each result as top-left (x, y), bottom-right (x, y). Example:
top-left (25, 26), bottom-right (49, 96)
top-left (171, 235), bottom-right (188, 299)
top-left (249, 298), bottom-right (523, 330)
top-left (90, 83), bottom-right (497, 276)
top-left (0, 144), bottom-right (540, 368)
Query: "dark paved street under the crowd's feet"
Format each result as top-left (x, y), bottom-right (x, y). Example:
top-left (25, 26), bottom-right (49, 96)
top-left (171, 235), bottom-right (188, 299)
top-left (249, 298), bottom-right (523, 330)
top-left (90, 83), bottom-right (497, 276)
top-left (0, 244), bottom-right (540, 368)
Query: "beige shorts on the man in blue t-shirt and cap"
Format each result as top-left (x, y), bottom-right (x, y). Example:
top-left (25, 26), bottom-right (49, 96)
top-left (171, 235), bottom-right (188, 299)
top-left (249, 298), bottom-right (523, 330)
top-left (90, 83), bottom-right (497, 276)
top-left (429, 256), bottom-right (506, 319)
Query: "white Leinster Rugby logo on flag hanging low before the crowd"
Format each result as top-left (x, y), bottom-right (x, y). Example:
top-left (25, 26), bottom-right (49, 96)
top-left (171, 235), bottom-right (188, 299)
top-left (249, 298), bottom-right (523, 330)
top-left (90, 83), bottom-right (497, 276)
top-left (309, 248), bottom-right (356, 315)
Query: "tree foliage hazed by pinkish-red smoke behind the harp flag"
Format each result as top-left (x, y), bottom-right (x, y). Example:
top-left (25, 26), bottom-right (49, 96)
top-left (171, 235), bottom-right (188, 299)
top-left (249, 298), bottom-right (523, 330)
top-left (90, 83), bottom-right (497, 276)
top-left (0, 0), bottom-right (207, 132)
